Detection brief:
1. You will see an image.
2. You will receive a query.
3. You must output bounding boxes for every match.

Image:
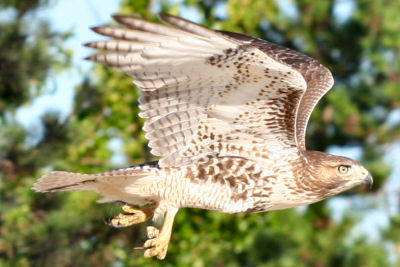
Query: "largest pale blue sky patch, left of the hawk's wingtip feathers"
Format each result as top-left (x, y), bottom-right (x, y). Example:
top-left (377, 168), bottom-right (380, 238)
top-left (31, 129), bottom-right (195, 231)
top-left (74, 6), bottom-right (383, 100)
top-left (17, 0), bottom-right (119, 131)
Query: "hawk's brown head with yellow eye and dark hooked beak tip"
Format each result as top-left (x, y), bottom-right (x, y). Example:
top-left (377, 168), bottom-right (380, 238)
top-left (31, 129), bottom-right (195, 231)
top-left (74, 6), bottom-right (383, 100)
top-left (306, 151), bottom-right (373, 198)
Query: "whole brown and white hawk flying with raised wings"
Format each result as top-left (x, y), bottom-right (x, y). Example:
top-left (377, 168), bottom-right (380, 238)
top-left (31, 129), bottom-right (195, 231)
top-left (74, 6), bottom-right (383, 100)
top-left (33, 15), bottom-right (372, 259)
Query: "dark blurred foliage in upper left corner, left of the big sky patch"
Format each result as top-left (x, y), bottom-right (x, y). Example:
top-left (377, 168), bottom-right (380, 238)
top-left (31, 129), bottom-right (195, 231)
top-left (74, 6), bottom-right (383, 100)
top-left (0, 1), bottom-right (71, 116)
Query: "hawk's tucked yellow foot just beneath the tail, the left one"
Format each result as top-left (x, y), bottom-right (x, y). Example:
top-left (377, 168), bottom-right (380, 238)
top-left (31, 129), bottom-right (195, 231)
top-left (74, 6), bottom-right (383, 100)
top-left (110, 204), bottom-right (156, 227)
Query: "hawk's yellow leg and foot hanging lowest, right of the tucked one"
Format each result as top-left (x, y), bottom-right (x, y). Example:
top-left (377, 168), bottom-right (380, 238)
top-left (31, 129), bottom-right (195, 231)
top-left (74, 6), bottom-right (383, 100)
top-left (143, 209), bottom-right (178, 260)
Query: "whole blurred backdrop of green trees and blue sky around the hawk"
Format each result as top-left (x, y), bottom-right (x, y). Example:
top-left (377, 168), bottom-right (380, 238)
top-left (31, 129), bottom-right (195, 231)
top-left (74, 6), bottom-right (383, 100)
top-left (0, 0), bottom-right (400, 267)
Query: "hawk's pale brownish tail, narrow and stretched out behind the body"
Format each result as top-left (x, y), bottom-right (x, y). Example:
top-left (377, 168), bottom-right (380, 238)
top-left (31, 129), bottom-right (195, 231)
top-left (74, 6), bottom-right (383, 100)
top-left (32, 166), bottom-right (161, 204)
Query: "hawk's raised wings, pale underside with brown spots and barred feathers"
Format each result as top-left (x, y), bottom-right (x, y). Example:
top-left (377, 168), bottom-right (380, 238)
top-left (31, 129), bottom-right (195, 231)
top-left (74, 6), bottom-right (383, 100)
top-left (87, 15), bottom-right (333, 167)
